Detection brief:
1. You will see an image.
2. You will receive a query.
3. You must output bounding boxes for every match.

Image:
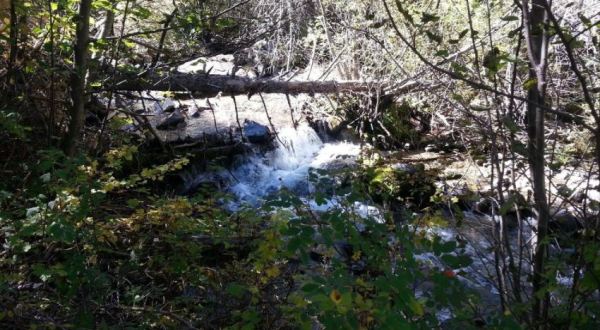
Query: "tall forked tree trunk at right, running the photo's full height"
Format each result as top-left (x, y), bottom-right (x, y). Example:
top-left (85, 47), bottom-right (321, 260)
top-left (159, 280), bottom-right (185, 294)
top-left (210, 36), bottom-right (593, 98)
top-left (522, 0), bottom-right (550, 328)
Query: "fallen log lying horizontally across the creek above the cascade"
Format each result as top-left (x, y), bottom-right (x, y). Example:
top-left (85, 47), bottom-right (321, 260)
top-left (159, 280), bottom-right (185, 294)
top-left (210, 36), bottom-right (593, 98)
top-left (109, 73), bottom-right (420, 97)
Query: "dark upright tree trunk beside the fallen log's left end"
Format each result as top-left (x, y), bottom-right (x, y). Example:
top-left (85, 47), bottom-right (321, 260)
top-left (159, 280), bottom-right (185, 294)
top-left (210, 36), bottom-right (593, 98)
top-left (64, 0), bottom-right (92, 156)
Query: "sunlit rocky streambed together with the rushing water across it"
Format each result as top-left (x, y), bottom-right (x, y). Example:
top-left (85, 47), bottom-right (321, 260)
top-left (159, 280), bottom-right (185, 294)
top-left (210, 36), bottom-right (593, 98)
top-left (110, 52), bottom-right (600, 318)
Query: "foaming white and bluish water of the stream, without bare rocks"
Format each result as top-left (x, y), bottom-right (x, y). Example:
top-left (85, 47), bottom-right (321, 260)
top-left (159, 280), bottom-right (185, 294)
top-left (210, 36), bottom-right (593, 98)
top-left (182, 124), bottom-right (528, 320)
